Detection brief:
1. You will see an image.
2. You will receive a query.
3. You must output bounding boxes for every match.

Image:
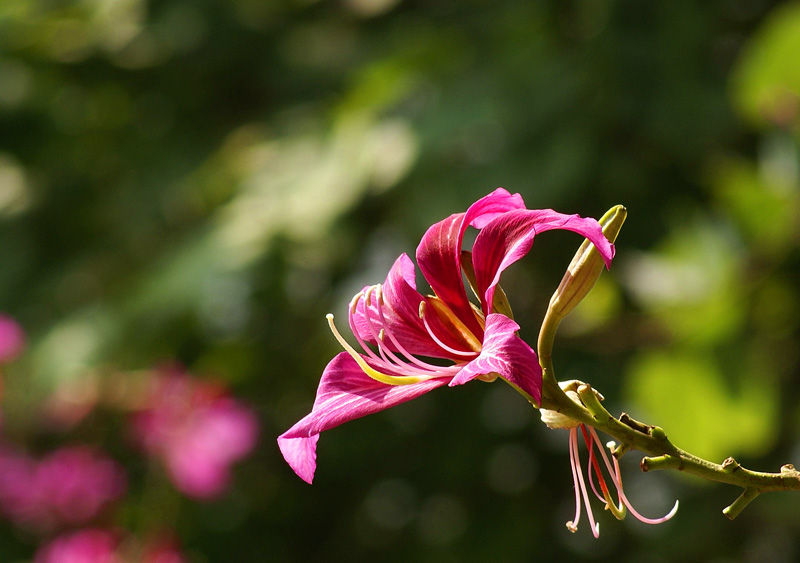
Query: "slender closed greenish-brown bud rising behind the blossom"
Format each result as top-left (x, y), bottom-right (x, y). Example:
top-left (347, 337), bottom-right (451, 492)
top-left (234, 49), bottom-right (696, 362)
top-left (547, 205), bottom-right (628, 323)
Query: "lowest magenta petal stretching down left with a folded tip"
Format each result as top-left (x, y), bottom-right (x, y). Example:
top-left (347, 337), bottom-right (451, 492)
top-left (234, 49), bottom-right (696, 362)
top-left (278, 352), bottom-right (450, 483)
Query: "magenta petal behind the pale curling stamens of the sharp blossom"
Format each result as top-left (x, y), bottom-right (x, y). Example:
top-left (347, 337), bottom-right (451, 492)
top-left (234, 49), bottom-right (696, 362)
top-left (353, 254), bottom-right (469, 359)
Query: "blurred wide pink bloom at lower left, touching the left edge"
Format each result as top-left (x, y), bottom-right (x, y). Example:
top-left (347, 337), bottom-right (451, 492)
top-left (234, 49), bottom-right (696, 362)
top-left (0, 446), bottom-right (126, 530)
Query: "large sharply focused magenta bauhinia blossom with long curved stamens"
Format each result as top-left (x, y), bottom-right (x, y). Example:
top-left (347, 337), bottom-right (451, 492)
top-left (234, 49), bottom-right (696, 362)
top-left (278, 188), bottom-right (614, 483)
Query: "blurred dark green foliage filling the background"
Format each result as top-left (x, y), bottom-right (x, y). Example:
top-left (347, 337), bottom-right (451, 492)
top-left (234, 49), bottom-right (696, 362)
top-left (0, 0), bottom-right (800, 562)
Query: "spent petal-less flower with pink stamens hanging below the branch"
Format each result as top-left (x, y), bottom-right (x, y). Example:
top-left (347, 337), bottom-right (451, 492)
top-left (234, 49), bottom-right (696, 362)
top-left (540, 380), bottom-right (678, 537)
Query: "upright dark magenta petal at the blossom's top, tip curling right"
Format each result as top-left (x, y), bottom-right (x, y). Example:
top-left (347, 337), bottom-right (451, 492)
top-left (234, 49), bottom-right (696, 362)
top-left (417, 188), bottom-right (525, 338)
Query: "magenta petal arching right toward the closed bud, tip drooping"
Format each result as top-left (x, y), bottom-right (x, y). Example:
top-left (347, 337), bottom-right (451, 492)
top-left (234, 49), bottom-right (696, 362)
top-left (472, 209), bottom-right (614, 311)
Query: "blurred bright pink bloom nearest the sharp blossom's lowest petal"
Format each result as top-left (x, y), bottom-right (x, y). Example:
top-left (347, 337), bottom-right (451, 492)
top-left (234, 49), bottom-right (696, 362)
top-left (133, 370), bottom-right (258, 499)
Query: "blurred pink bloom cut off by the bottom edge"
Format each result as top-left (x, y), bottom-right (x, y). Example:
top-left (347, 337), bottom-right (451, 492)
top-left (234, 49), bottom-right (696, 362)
top-left (34, 528), bottom-right (125, 563)
